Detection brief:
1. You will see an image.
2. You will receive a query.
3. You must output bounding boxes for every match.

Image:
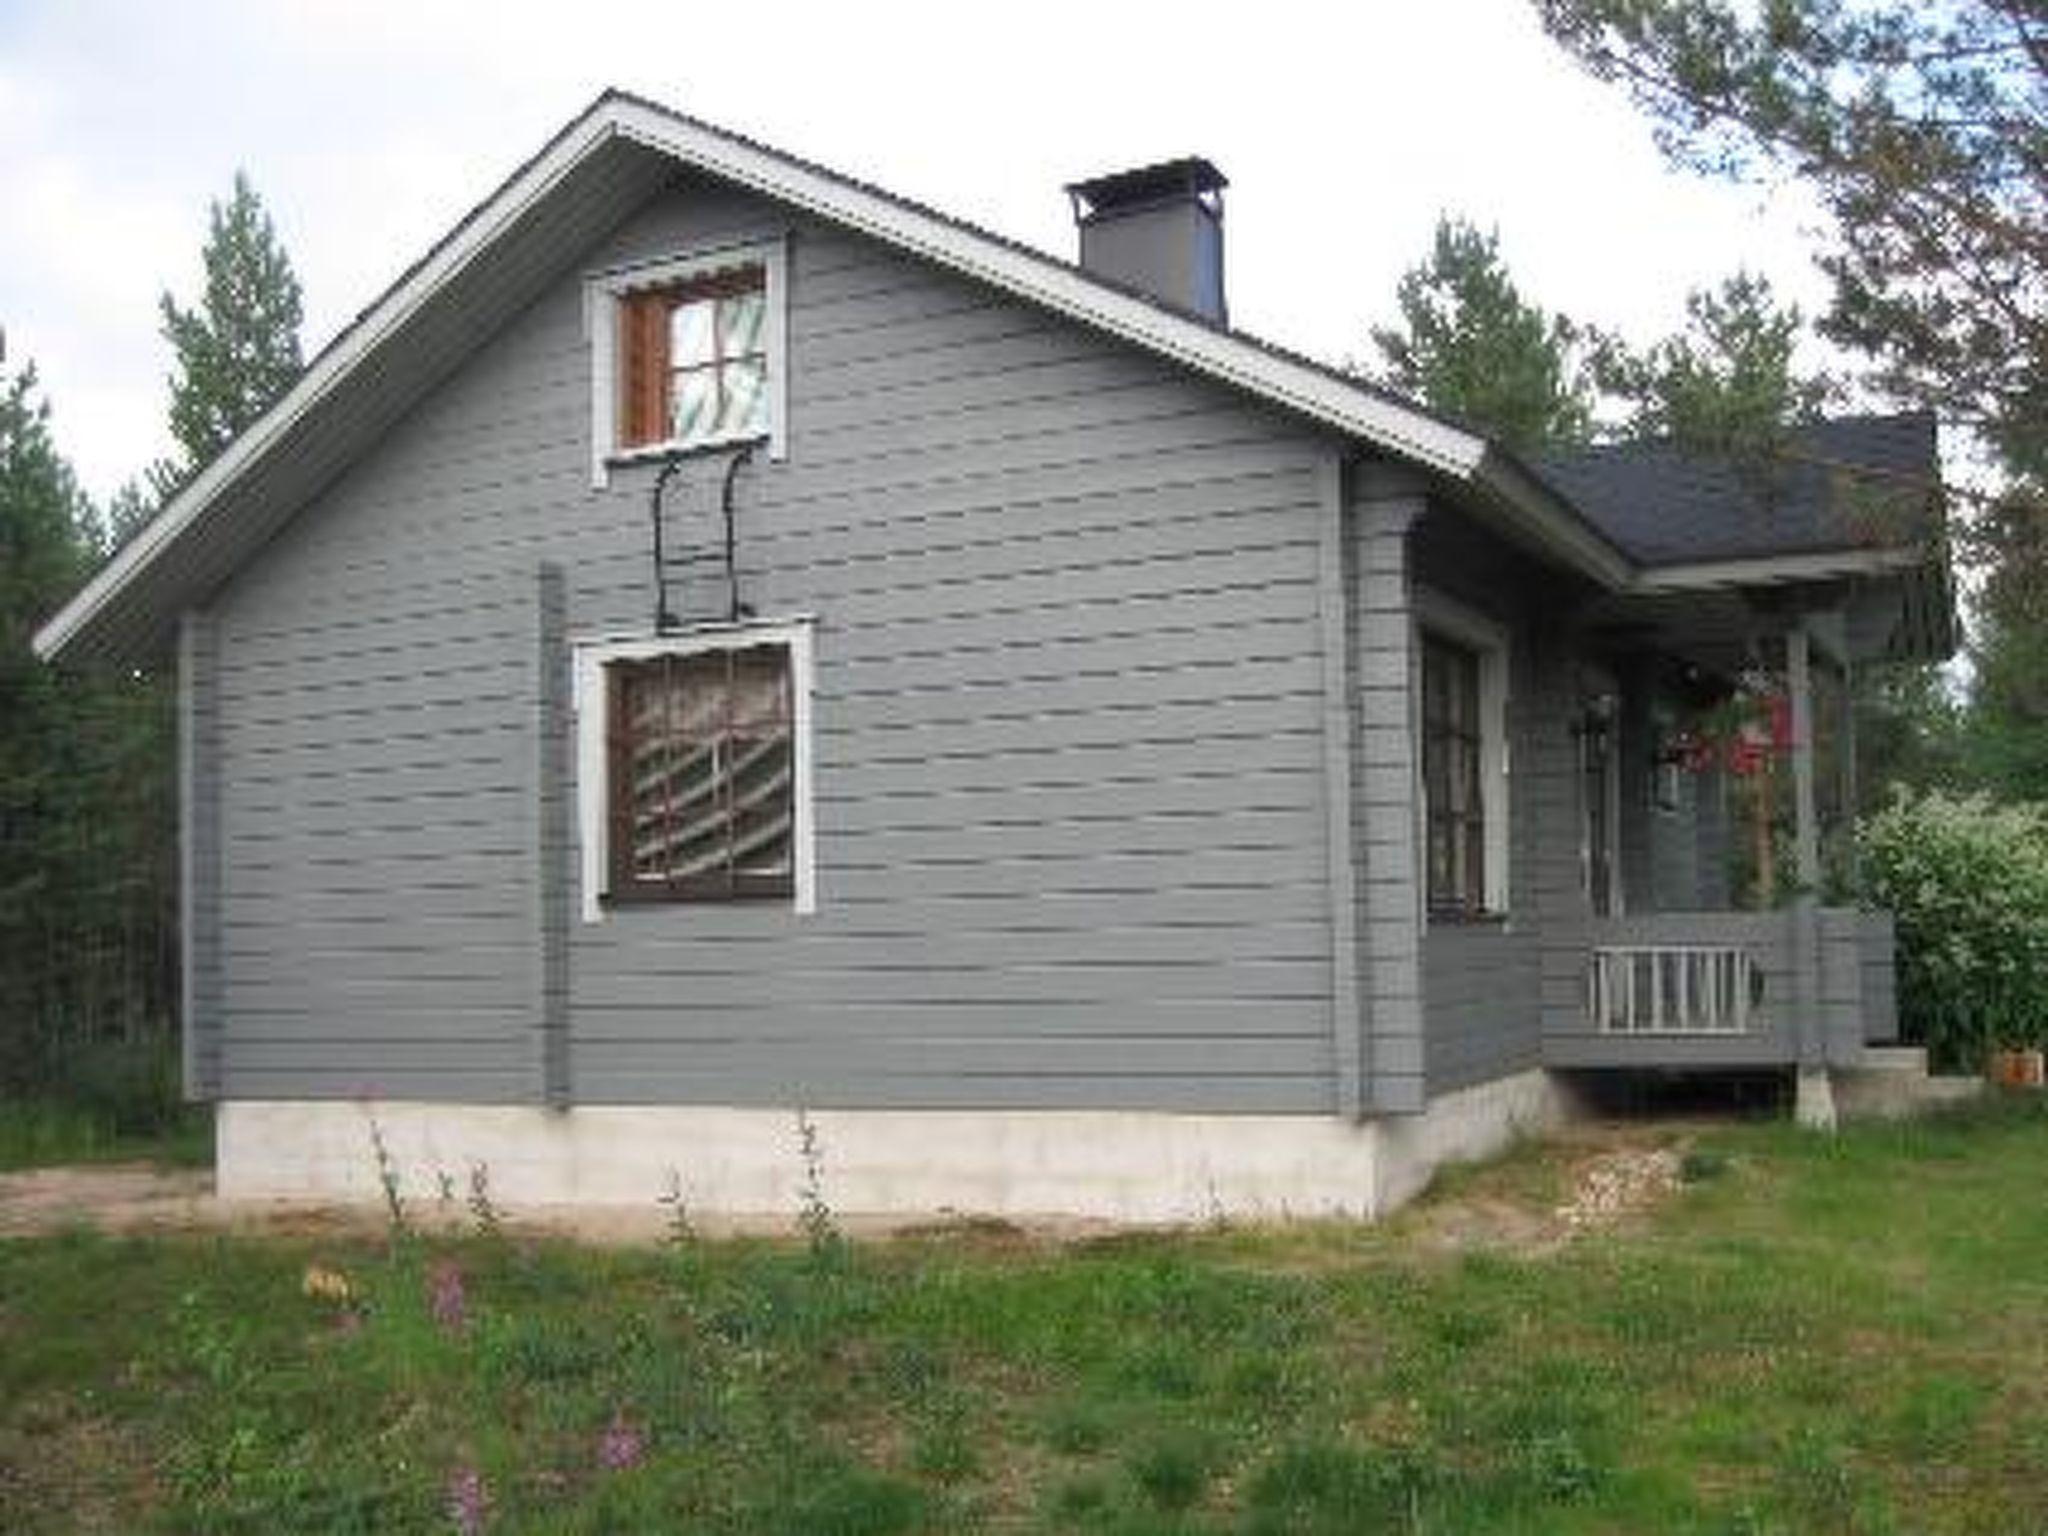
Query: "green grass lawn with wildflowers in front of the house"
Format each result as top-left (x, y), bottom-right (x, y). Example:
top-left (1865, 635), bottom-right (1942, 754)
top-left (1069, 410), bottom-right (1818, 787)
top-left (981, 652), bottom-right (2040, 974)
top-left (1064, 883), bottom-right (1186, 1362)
top-left (0, 1104), bottom-right (2048, 1536)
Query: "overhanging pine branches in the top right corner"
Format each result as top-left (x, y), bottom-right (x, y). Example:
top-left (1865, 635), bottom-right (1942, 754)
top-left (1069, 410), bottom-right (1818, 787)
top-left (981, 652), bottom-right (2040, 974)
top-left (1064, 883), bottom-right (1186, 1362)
top-left (1532, 0), bottom-right (2048, 799)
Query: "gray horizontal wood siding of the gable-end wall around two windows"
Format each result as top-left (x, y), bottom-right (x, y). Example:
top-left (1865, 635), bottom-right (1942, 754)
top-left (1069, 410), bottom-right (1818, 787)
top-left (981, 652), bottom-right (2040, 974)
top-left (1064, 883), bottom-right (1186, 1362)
top-left (203, 184), bottom-right (1335, 1112)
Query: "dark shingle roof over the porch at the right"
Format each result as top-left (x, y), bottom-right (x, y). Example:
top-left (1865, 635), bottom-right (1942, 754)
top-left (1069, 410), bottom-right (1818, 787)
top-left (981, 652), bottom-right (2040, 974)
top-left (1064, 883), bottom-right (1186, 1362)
top-left (1536, 414), bottom-right (1939, 565)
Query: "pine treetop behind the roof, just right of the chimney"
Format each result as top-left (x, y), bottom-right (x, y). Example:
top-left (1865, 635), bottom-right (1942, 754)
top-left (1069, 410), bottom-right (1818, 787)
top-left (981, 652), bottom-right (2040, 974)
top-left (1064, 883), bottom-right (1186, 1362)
top-left (1372, 217), bottom-right (1593, 451)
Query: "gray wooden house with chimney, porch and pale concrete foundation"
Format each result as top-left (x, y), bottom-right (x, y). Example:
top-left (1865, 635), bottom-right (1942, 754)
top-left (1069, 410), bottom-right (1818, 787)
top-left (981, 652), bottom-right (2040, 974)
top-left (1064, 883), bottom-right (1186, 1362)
top-left (37, 94), bottom-right (1950, 1217)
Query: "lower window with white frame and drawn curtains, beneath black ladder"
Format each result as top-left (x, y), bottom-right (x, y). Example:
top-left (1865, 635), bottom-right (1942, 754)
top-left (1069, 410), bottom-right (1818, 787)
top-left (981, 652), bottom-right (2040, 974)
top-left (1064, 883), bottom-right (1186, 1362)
top-left (578, 625), bottom-right (811, 918)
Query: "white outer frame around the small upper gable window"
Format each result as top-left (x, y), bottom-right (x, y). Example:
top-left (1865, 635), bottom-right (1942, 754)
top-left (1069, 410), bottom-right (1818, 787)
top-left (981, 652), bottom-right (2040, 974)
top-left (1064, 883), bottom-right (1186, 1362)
top-left (584, 240), bottom-right (788, 492)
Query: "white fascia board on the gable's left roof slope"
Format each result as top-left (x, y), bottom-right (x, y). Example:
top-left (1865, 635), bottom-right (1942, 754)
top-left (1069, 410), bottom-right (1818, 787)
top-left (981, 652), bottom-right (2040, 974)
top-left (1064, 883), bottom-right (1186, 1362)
top-left (33, 111), bottom-right (614, 662)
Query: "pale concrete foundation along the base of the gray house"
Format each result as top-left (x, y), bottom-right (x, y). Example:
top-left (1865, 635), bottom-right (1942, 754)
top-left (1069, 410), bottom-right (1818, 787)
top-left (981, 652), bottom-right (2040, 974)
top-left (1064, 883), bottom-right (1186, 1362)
top-left (217, 1071), bottom-right (1571, 1223)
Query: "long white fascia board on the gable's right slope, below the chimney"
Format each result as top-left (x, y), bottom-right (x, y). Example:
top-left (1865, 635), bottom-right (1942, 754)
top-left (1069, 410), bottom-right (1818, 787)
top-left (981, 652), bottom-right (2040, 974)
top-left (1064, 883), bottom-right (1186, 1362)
top-left (616, 100), bottom-right (1487, 479)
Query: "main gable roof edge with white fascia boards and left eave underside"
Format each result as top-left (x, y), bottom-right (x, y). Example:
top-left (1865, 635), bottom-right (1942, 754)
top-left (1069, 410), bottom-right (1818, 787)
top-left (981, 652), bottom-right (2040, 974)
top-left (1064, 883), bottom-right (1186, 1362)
top-left (35, 92), bottom-right (1632, 657)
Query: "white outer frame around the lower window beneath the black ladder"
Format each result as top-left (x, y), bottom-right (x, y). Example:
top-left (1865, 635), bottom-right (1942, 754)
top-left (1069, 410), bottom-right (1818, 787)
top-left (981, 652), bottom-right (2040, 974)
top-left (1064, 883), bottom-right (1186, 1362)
top-left (569, 614), bottom-right (817, 924)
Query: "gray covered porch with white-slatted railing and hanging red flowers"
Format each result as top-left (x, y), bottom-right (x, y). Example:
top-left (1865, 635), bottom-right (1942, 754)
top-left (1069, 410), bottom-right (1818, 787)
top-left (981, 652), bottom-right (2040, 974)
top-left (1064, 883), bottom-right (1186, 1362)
top-left (1542, 540), bottom-right (1946, 1073)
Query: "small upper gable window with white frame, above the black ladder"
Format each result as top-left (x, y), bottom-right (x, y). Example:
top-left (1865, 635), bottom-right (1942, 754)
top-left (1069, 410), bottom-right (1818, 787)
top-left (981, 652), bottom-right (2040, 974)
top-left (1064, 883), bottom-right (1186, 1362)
top-left (590, 242), bottom-right (786, 485)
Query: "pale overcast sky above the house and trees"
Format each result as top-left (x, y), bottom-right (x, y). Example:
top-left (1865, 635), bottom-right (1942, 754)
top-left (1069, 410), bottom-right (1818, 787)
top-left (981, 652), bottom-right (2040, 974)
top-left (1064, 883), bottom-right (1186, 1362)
top-left (0, 0), bottom-right (1823, 496)
